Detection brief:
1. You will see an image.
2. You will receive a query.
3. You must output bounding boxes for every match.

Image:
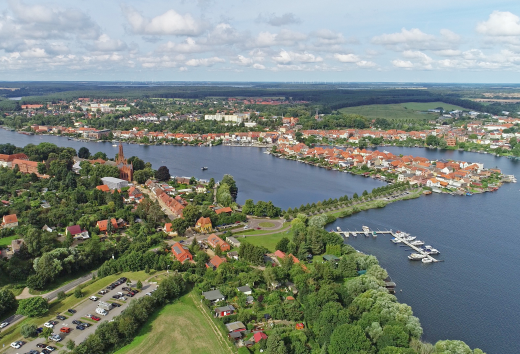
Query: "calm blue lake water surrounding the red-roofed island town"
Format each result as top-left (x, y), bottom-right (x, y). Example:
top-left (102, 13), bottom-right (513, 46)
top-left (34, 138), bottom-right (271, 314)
top-left (0, 130), bottom-right (520, 354)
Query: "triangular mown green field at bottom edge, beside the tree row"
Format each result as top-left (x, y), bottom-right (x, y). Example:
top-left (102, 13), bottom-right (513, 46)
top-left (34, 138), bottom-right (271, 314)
top-left (116, 292), bottom-right (235, 354)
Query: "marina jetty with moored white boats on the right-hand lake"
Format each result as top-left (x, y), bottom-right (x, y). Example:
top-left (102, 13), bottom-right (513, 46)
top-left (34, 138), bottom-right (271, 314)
top-left (331, 226), bottom-right (444, 263)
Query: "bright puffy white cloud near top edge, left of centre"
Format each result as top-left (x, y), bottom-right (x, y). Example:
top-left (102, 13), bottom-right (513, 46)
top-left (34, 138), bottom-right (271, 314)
top-left (121, 4), bottom-right (205, 36)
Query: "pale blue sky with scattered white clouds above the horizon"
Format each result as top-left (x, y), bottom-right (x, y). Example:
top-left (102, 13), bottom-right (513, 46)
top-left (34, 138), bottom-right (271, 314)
top-left (0, 0), bottom-right (520, 83)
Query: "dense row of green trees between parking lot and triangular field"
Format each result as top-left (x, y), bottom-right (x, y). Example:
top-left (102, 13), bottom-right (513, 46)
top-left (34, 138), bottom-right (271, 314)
top-left (72, 275), bottom-right (186, 354)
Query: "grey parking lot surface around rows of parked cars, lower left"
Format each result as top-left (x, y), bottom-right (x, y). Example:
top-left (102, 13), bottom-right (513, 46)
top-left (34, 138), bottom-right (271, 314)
top-left (3, 282), bottom-right (156, 354)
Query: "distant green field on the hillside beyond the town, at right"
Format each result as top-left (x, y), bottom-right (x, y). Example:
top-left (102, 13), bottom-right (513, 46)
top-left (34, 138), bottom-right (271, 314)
top-left (340, 102), bottom-right (464, 119)
